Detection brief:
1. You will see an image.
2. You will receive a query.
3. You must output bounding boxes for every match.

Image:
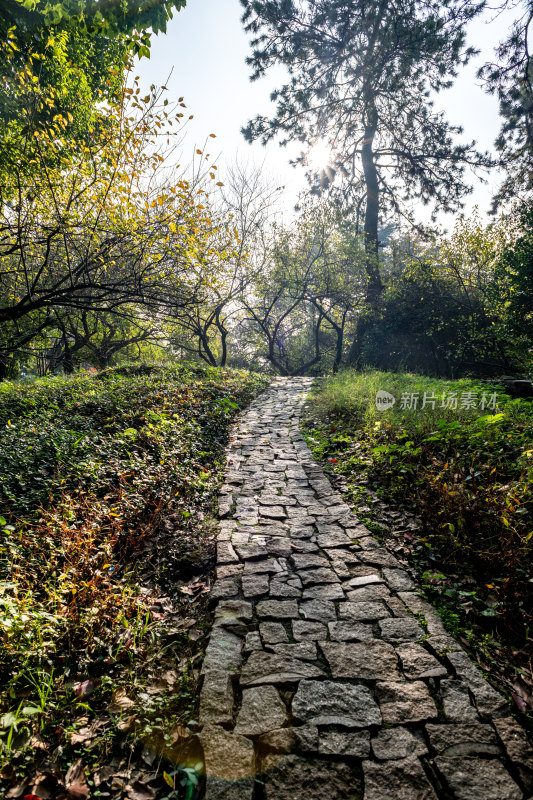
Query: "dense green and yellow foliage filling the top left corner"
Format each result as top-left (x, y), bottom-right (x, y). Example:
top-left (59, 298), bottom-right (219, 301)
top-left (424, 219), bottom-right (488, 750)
top-left (0, 0), bottom-right (185, 191)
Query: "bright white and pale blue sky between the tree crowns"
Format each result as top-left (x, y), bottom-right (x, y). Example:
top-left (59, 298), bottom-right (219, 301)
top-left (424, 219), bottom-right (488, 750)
top-left (135, 0), bottom-right (513, 228)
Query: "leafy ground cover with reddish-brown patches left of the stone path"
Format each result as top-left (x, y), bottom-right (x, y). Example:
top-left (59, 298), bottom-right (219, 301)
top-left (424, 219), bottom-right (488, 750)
top-left (0, 364), bottom-right (267, 800)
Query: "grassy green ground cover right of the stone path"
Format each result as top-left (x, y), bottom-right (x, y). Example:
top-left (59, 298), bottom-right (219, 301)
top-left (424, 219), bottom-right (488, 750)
top-left (304, 371), bottom-right (533, 712)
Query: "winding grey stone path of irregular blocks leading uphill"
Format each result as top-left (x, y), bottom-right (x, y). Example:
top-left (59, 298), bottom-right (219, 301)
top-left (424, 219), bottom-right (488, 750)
top-left (199, 378), bottom-right (533, 800)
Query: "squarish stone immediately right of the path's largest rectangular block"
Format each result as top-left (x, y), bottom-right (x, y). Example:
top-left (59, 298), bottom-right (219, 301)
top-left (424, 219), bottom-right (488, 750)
top-left (376, 681), bottom-right (437, 725)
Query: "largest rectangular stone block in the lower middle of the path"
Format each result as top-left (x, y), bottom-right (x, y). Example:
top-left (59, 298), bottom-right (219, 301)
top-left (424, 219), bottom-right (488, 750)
top-left (292, 680), bottom-right (381, 728)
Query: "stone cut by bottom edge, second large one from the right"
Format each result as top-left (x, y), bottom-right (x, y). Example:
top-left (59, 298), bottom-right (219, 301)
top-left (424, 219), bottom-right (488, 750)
top-left (363, 758), bottom-right (437, 800)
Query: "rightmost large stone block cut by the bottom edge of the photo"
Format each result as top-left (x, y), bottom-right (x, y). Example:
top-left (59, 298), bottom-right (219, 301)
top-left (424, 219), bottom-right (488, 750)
top-left (435, 756), bottom-right (524, 800)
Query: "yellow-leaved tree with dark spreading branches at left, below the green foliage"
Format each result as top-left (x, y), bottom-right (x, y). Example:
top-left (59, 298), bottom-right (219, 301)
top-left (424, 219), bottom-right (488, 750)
top-left (0, 78), bottom-right (222, 376)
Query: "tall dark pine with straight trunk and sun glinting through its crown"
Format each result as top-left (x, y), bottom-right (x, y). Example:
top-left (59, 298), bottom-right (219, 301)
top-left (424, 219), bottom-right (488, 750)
top-left (241, 0), bottom-right (490, 357)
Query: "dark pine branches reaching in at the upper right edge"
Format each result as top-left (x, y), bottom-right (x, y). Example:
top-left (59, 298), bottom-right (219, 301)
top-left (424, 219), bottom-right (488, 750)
top-left (479, 0), bottom-right (533, 209)
